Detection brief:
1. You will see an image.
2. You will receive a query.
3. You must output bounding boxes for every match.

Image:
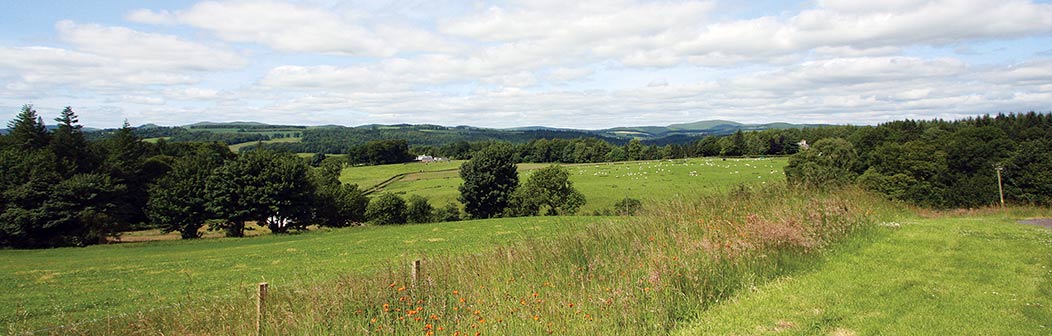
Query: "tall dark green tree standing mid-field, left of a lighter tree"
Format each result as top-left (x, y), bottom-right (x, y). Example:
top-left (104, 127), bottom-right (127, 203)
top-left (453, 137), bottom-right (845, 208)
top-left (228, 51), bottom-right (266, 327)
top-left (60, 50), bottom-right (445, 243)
top-left (459, 143), bottom-right (519, 218)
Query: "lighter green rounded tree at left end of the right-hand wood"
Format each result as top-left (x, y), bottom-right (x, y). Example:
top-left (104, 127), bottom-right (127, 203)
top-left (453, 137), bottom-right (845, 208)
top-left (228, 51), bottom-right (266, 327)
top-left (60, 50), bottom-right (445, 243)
top-left (785, 138), bottom-right (857, 186)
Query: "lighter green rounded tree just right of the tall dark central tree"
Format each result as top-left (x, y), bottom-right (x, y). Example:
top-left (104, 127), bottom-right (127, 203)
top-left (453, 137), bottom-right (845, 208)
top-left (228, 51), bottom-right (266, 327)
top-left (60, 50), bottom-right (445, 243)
top-left (514, 165), bottom-right (585, 216)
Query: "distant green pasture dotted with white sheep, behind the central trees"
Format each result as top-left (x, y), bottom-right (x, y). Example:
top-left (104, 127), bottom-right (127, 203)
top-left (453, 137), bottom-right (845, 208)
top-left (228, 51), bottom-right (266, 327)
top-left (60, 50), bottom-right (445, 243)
top-left (341, 158), bottom-right (787, 214)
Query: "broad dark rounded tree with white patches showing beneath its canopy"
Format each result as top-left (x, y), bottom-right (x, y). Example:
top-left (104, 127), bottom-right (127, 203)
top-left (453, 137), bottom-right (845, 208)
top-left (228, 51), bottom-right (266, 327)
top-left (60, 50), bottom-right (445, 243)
top-left (205, 150), bottom-right (313, 237)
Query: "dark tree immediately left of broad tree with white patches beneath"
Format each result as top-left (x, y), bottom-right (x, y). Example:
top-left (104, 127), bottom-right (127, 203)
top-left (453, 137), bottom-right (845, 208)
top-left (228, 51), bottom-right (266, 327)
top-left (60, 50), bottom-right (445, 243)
top-left (146, 151), bottom-right (224, 239)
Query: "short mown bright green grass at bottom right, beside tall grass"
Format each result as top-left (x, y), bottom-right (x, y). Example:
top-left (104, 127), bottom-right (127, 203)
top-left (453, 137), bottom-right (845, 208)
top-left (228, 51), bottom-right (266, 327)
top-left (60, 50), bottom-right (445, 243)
top-left (680, 214), bottom-right (1052, 335)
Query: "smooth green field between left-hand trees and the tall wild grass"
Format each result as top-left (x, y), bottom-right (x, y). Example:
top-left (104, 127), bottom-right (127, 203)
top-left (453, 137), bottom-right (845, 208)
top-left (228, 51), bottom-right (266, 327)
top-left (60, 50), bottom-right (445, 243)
top-left (0, 217), bottom-right (608, 330)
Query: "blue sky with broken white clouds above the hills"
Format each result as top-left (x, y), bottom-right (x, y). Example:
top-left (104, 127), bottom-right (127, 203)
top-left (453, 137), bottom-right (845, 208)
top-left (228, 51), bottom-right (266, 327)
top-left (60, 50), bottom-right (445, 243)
top-left (0, 0), bottom-right (1052, 130)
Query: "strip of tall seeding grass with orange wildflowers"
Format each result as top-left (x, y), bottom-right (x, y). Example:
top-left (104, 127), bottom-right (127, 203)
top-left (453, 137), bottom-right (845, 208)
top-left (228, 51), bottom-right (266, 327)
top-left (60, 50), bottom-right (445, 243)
top-left (74, 185), bottom-right (895, 335)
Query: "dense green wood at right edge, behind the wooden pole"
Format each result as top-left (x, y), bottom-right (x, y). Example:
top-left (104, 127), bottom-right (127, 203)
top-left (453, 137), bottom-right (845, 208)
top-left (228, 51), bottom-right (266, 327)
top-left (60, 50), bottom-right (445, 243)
top-left (786, 112), bottom-right (1052, 207)
